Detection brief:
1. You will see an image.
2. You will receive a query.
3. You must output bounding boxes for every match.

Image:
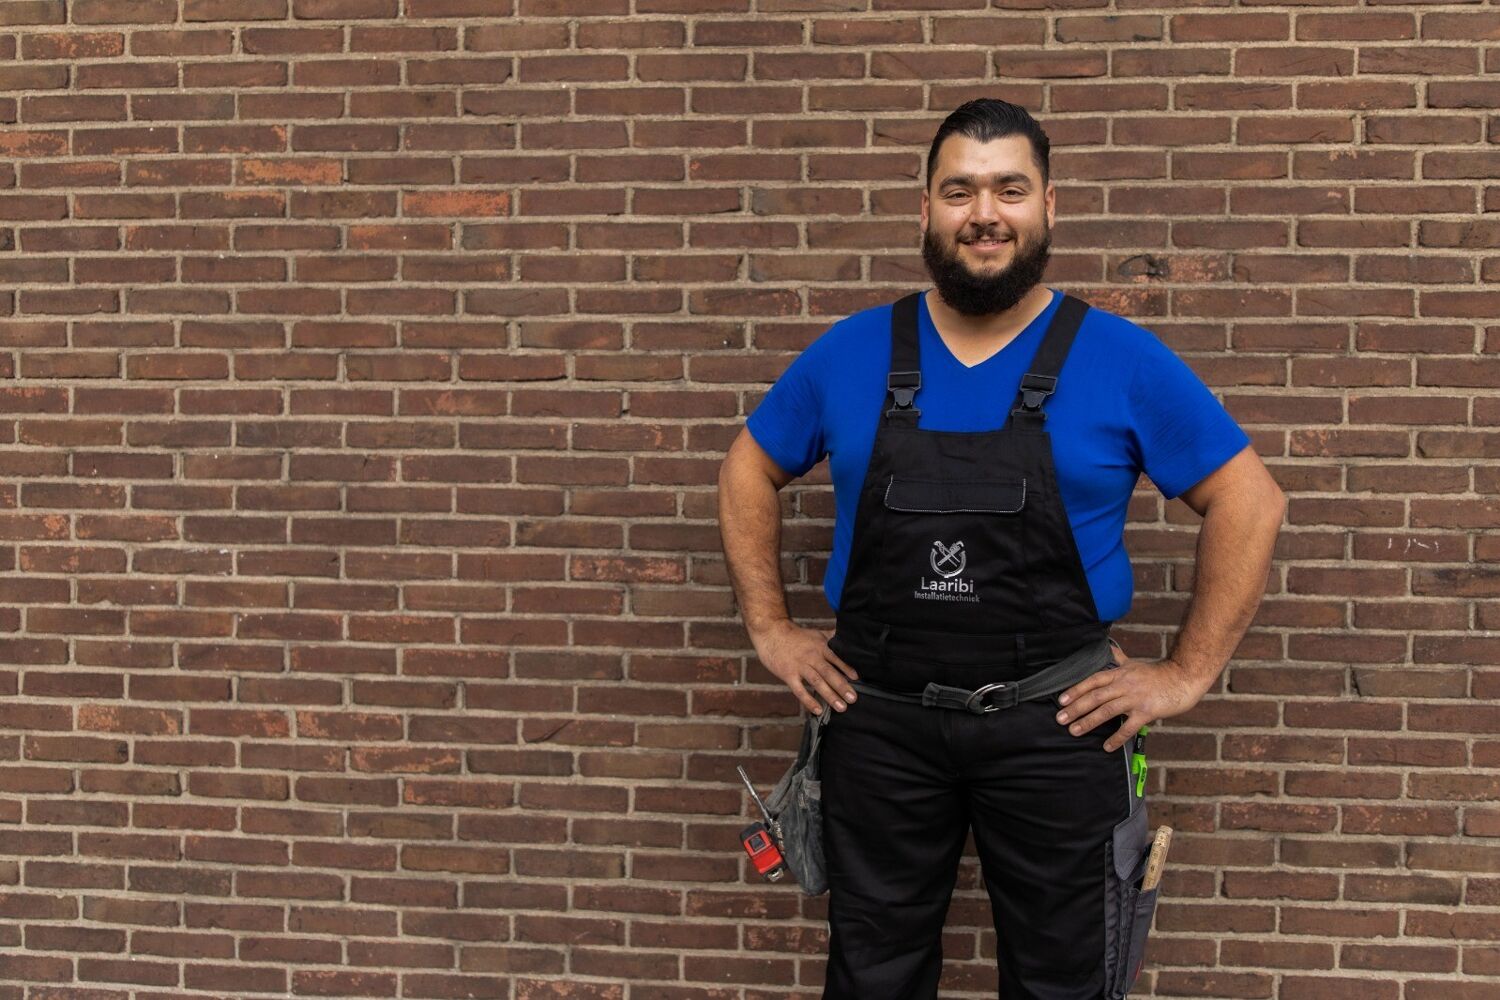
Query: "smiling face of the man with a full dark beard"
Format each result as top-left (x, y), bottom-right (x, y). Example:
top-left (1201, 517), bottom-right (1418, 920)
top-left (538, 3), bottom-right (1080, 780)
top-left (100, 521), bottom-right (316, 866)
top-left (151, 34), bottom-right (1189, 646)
top-left (923, 135), bottom-right (1056, 316)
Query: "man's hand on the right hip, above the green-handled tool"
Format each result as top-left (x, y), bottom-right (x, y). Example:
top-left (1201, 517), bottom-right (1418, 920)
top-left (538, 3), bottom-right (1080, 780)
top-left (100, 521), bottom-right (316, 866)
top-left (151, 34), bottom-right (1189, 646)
top-left (1058, 646), bottom-right (1208, 753)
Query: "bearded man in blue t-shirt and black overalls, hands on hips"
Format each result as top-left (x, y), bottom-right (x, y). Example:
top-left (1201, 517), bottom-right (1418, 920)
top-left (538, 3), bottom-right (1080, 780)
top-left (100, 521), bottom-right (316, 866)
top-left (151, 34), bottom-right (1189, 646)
top-left (719, 99), bottom-right (1286, 1000)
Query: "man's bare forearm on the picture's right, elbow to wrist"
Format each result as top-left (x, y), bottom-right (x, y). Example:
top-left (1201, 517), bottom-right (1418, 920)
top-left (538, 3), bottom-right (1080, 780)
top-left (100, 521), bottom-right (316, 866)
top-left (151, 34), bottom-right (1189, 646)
top-left (1170, 493), bottom-right (1286, 691)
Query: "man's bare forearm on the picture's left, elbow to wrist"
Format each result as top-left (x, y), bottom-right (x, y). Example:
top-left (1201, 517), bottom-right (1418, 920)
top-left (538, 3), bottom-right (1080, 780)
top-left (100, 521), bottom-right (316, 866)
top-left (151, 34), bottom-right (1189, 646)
top-left (719, 465), bottom-right (791, 637)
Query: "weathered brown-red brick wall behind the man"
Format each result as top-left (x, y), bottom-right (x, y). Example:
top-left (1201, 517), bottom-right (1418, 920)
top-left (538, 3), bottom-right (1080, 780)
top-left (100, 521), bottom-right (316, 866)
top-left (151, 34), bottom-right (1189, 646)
top-left (0, 0), bottom-right (1500, 1000)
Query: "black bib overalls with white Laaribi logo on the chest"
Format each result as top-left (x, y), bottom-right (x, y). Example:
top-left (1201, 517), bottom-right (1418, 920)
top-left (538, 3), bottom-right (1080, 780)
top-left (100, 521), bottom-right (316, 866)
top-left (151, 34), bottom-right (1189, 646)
top-left (822, 292), bottom-right (1146, 1000)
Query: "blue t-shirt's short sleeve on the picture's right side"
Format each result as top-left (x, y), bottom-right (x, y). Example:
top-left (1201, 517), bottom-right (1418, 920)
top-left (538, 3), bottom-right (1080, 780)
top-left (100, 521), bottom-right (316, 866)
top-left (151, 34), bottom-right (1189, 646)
top-left (1130, 330), bottom-right (1250, 499)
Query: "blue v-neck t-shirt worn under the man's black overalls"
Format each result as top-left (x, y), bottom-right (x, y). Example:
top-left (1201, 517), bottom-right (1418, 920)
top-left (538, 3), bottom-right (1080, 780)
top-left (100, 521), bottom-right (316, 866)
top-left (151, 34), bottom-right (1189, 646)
top-left (746, 289), bottom-right (1250, 622)
